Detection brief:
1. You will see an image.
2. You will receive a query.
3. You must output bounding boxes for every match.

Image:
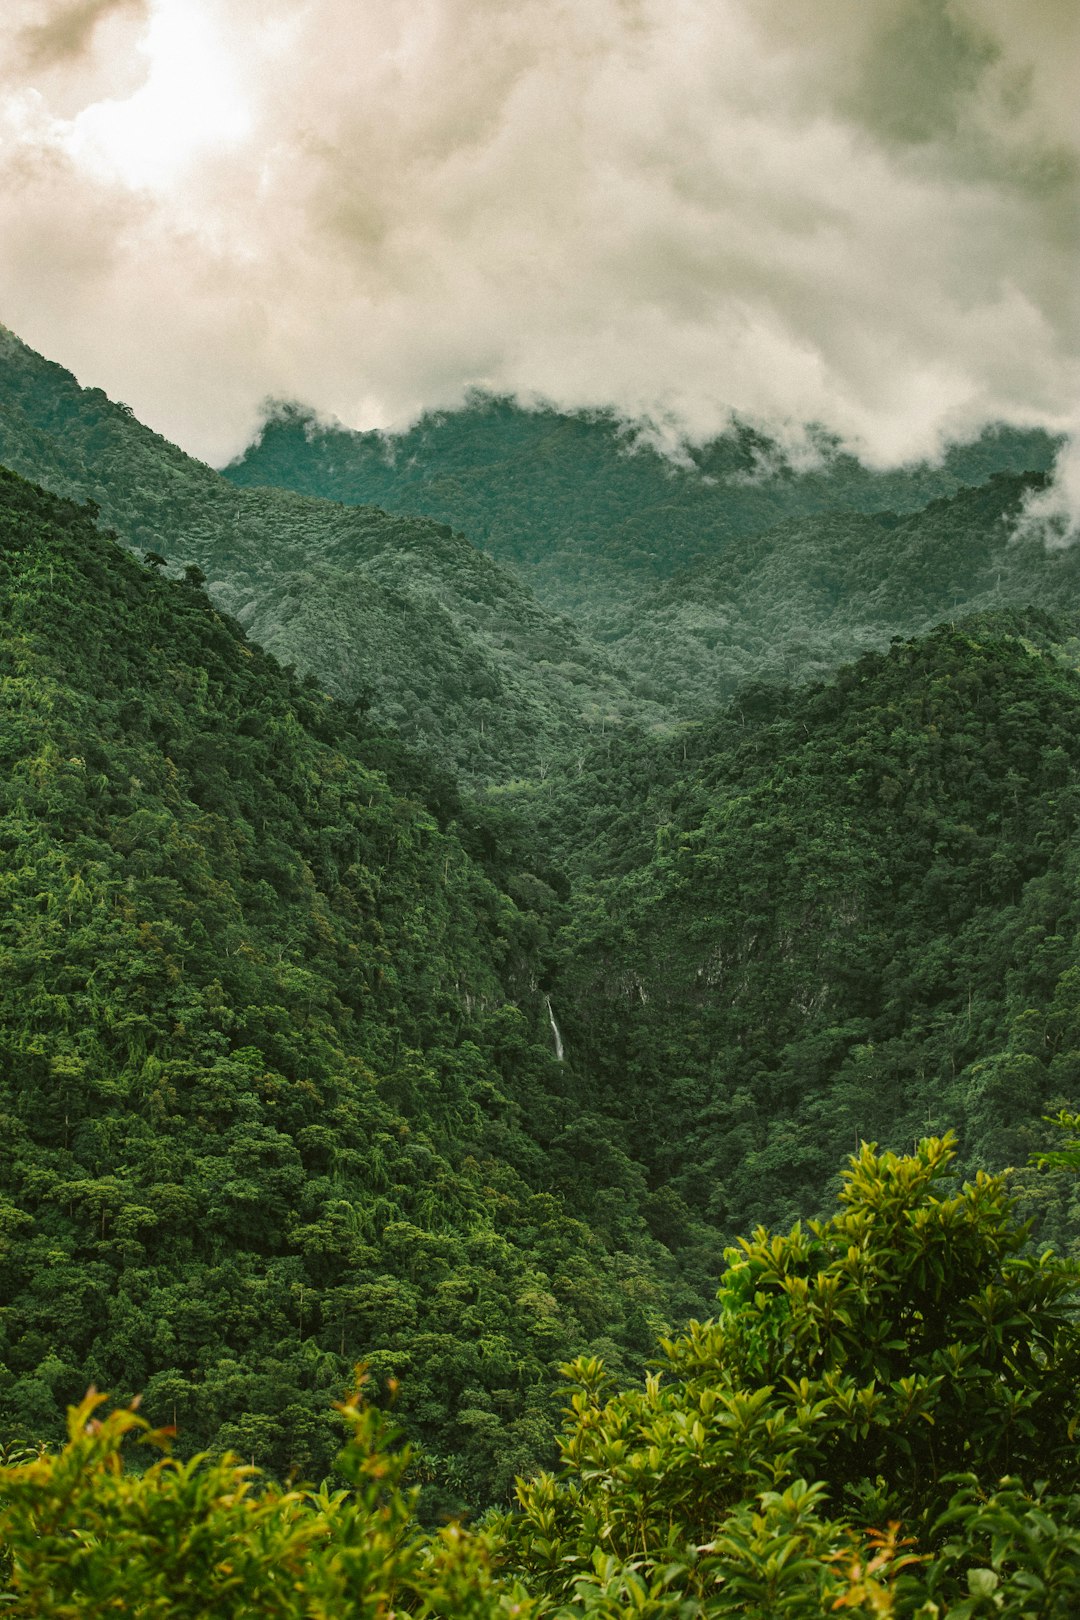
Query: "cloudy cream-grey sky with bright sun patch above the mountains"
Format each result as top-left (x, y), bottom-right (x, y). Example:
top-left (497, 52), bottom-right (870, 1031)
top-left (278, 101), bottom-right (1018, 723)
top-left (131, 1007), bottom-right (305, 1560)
top-left (0, 0), bottom-right (1080, 530)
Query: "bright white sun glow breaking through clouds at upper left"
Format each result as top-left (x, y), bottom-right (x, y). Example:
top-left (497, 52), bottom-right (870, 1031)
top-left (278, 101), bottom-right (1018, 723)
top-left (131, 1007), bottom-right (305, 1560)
top-left (63, 0), bottom-right (249, 190)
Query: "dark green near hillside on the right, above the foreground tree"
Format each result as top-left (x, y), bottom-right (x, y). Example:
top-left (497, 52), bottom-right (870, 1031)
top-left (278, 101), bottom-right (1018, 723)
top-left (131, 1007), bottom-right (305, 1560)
top-left (534, 612), bottom-right (1080, 1241)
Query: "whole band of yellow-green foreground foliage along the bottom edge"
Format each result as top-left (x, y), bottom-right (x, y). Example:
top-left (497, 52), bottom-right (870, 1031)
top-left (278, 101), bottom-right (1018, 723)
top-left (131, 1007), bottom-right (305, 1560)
top-left (0, 1139), bottom-right (1080, 1620)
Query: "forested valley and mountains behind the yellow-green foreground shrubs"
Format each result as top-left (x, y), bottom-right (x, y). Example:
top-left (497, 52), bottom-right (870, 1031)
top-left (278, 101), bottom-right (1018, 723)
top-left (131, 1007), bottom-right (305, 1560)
top-left (0, 332), bottom-right (1080, 1612)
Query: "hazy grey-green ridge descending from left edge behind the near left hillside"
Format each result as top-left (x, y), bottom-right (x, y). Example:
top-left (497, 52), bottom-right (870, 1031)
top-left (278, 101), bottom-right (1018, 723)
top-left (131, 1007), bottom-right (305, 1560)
top-left (0, 327), bottom-right (657, 781)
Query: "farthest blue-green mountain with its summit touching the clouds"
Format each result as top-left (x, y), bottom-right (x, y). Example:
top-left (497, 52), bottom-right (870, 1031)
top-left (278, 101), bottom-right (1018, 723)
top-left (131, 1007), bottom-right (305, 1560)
top-left (225, 397), bottom-right (1054, 618)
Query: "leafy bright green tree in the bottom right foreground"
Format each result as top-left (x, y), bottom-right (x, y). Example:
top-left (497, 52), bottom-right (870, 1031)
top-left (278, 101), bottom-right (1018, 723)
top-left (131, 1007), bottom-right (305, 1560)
top-left (505, 1137), bottom-right (1080, 1617)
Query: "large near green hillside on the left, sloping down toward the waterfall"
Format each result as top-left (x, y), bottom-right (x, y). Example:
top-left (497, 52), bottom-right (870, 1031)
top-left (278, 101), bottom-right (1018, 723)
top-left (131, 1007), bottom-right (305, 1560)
top-left (0, 473), bottom-right (699, 1502)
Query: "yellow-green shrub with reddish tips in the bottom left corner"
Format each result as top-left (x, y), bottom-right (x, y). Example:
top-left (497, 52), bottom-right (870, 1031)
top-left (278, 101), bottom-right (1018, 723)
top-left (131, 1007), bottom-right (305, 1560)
top-left (0, 1393), bottom-right (528, 1620)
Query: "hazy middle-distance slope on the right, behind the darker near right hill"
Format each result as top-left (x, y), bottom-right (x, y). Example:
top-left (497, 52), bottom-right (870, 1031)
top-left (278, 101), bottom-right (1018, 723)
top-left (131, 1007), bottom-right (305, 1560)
top-left (610, 473), bottom-right (1080, 718)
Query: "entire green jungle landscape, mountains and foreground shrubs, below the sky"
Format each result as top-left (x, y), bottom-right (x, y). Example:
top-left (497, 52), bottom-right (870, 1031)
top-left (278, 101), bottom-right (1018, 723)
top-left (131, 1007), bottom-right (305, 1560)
top-left (0, 330), bottom-right (1080, 1620)
